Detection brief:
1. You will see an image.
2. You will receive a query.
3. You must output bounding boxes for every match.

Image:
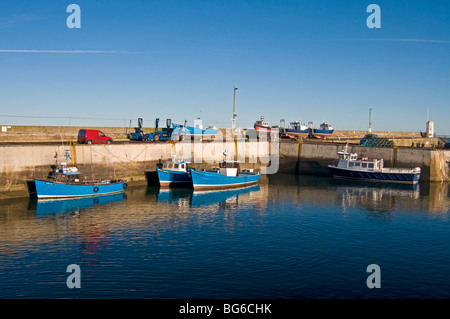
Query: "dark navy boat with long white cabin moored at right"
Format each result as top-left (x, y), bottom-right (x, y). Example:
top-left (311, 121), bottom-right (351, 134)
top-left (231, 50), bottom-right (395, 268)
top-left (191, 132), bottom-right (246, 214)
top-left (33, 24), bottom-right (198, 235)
top-left (328, 145), bottom-right (421, 184)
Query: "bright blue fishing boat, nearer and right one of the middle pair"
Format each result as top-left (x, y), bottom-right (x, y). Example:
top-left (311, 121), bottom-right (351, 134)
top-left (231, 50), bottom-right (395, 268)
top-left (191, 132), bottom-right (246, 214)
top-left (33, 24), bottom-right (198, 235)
top-left (191, 153), bottom-right (261, 190)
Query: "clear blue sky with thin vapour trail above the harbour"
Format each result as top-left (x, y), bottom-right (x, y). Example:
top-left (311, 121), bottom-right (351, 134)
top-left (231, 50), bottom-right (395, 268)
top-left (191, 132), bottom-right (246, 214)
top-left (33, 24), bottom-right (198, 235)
top-left (0, 0), bottom-right (450, 134)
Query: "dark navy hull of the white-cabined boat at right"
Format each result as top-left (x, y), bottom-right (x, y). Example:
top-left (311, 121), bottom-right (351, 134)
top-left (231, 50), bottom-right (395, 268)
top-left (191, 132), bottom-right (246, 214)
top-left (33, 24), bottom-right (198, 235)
top-left (328, 165), bottom-right (420, 184)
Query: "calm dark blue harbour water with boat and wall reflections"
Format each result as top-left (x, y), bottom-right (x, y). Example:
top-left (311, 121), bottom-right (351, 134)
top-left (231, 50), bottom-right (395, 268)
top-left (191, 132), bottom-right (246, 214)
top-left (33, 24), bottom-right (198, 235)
top-left (0, 174), bottom-right (450, 299)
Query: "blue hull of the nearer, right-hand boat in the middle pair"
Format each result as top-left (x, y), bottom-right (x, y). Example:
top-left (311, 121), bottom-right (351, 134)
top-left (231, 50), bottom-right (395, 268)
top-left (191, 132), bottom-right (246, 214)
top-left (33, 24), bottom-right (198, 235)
top-left (191, 168), bottom-right (261, 189)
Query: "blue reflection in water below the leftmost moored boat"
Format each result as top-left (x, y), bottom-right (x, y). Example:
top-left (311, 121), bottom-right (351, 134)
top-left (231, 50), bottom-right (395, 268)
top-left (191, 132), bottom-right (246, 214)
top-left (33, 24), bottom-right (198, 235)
top-left (30, 193), bottom-right (126, 216)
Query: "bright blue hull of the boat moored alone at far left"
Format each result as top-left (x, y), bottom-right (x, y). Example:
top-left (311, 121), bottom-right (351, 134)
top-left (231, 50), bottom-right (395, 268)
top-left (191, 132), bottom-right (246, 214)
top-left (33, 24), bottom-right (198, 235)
top-left (34, 180), bottom-right (127, 198)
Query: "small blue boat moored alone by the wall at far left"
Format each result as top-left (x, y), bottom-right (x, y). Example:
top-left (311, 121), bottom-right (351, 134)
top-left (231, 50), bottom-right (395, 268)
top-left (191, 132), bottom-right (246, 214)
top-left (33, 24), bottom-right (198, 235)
top-left (30, 163), bottom-right (127, 198)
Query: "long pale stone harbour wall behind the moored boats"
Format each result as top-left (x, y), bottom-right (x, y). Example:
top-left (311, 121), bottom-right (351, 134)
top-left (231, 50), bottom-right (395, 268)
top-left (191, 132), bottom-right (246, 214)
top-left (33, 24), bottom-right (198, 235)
top-left (0, 140), bottom-right (450, 199)
